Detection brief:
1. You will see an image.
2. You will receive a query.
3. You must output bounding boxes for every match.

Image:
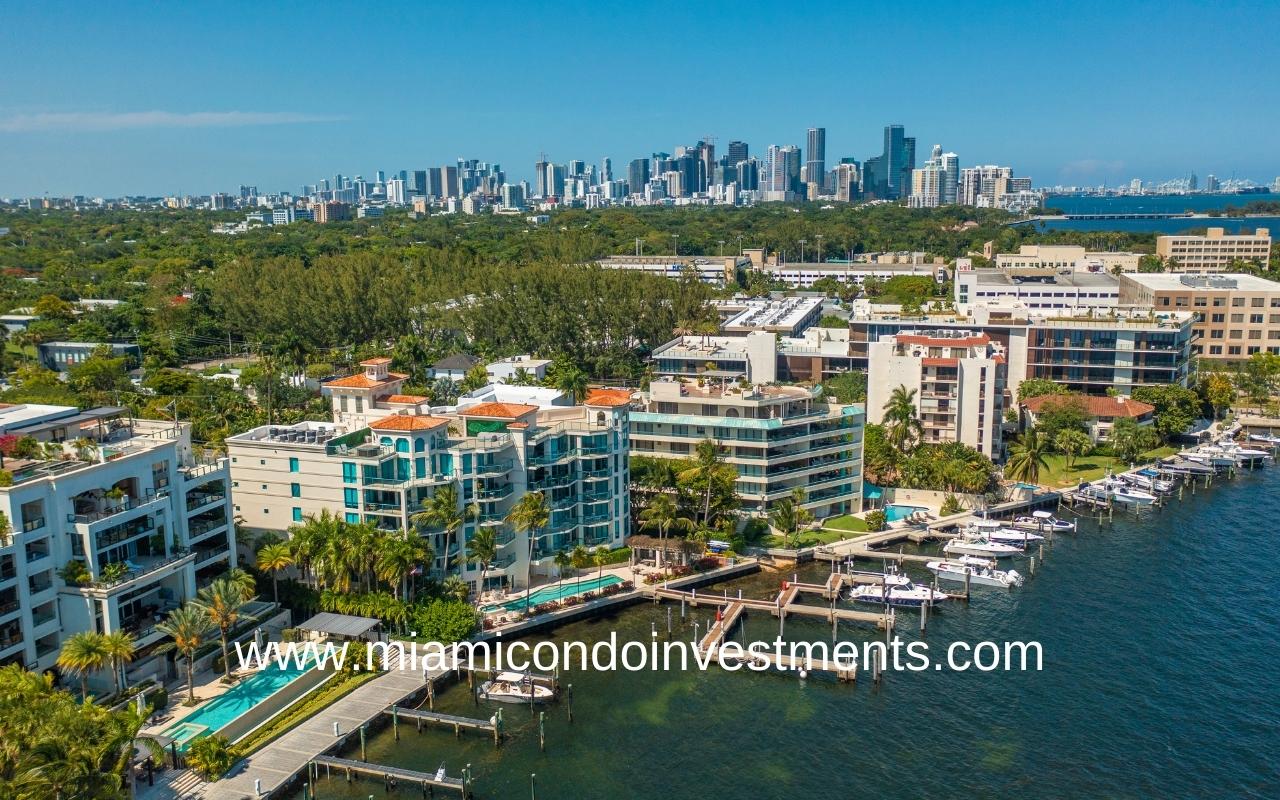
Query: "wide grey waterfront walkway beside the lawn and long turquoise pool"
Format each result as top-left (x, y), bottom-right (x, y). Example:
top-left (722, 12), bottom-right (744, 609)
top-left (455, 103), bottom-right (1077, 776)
top-left (200, 669), bottom-right (443, 800)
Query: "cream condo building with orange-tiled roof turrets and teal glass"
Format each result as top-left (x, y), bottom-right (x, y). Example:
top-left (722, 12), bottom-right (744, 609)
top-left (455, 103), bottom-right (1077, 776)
top-left (227, 358), bottom-right (631, 586)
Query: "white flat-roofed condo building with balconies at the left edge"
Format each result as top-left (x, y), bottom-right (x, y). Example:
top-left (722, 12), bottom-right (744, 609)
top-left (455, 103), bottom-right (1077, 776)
top-left (0, 404), bottom-right (234, 680)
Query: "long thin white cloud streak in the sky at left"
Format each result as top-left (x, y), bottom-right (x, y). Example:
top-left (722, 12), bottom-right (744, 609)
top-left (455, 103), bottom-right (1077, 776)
top-left (0, 111), bottom-right (342, 133)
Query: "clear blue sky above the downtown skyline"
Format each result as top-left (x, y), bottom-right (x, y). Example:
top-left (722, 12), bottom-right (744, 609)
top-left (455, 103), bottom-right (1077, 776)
top-left (0, 0), bottom-right (1280, 196)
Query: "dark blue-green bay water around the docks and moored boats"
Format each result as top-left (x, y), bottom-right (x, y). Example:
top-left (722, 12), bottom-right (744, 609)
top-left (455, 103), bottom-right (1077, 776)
top-left (293, 467), bottom-right (1280, 800)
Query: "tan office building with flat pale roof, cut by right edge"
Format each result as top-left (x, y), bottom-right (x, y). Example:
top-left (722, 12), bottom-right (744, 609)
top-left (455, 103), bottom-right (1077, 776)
top-left (1120, 273), bottom-right (1280, 361)
